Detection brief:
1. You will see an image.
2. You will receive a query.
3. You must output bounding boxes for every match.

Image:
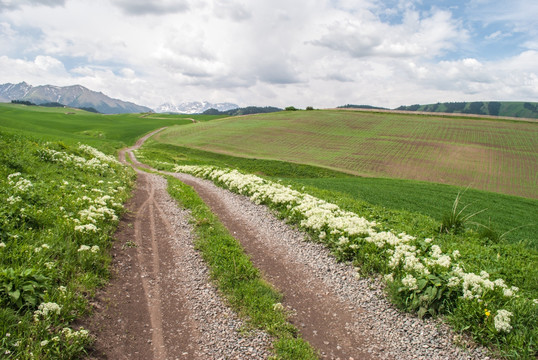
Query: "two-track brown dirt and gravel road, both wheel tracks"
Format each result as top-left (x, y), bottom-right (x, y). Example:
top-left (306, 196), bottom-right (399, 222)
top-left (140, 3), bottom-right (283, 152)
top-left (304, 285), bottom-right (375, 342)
top-left (82, 129), bottom-right (485, 359)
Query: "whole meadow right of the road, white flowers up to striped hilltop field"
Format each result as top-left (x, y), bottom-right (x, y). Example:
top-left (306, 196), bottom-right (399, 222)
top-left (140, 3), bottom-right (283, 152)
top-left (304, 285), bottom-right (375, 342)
top-left (138, 111), bottom-right (538, 358)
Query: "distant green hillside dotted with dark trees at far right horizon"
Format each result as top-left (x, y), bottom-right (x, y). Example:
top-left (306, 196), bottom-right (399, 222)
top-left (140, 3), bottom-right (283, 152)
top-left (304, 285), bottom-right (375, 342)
top-left (395, 101), bottom-right (538, 119)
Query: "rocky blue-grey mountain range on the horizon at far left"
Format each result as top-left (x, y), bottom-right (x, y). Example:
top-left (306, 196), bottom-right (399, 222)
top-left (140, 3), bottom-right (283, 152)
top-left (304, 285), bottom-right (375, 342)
top-left (0, 82), bottom-right (152, 114)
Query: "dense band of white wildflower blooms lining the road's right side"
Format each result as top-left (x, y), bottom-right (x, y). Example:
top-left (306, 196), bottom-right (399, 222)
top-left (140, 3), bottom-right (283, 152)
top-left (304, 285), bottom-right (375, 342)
top-left (174, 165), bottom-right (528, 333)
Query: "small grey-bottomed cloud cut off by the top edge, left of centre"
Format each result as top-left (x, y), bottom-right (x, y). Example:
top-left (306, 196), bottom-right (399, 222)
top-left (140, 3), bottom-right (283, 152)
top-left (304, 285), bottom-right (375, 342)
top-left (112, 0), bottom-right (190, 15)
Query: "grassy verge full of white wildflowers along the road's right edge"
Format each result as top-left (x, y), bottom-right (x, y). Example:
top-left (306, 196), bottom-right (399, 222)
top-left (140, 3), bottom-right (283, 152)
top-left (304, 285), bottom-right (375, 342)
top-left (161, 164), bottom-right (538, 359)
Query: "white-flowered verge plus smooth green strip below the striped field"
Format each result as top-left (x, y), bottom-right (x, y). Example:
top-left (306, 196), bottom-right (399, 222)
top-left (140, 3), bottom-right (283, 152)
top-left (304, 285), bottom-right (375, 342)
top-left (138, 117), bottom-right (538, 359)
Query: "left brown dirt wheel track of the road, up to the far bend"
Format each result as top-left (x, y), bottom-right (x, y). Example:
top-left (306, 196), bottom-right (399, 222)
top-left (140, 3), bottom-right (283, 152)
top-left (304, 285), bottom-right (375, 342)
top-left (83, 130), bottom-right (270, 360)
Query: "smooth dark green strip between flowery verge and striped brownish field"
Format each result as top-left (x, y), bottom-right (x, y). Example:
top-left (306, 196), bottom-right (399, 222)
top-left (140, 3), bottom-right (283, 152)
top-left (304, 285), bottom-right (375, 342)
top-left (140, 141), bottom-right (538, 250)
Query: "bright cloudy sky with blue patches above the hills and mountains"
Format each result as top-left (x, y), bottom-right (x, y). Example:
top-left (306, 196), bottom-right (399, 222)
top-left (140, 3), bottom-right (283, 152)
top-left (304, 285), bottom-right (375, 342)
top-left (0, 0), bottom-right (538, 108)
